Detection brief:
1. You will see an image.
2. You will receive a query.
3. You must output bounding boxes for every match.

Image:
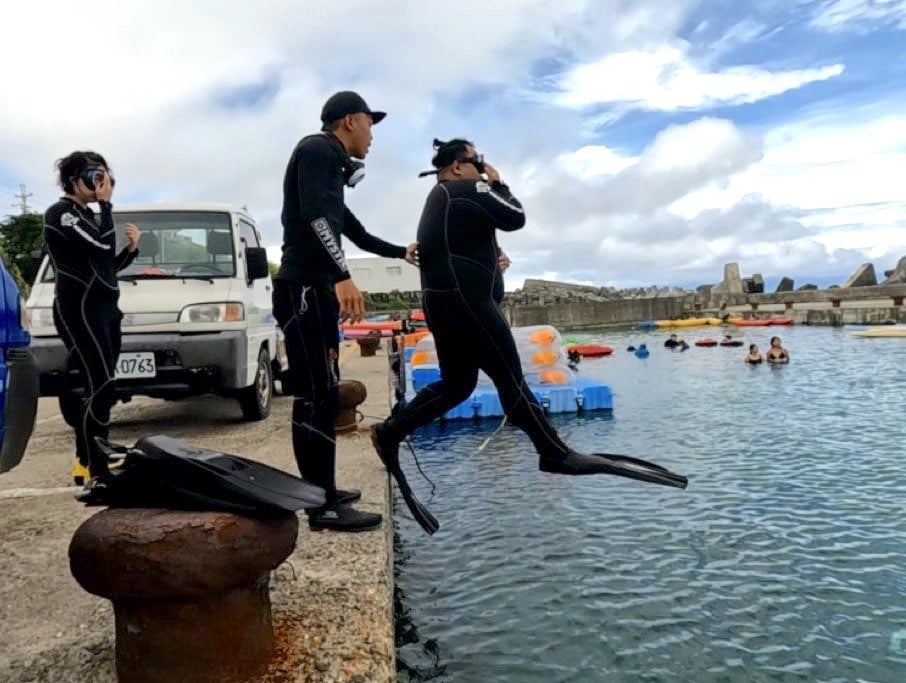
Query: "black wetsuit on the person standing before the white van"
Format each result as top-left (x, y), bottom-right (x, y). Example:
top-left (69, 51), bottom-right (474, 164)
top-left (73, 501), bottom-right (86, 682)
top-left (44, 199), bottom-right (138, 476)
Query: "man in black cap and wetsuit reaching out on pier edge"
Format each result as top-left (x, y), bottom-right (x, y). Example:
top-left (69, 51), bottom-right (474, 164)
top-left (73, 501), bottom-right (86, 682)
top-left (274, 91), bottom-right (416, 531)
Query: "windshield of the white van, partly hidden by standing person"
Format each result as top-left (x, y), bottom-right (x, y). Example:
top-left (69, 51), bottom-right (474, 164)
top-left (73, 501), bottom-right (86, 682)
top-left (42, 211), bottom-right (236, 282)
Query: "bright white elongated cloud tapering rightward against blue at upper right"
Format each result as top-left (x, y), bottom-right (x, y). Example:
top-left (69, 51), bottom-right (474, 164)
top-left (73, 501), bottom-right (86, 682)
top-left (554, 44), bottom-right (843, 111)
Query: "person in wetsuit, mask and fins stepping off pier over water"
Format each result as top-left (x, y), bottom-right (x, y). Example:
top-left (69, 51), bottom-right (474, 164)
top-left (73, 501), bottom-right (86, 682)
top-left (371, 139), bottom-right (687, 534)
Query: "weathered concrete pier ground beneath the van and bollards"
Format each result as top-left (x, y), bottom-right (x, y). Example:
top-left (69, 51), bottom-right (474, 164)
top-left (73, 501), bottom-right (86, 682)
top-left (0, 343), bottom-right (396, 683)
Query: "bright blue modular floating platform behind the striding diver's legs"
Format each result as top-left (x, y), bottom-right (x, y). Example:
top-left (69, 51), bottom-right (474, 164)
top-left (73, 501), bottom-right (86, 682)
top-left (406, 363), bottom-right (613, 420)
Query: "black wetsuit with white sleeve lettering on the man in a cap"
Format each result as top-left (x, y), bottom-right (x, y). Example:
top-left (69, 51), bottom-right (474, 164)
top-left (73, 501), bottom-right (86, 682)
top-left (273, 133), bottom-right (406, 495)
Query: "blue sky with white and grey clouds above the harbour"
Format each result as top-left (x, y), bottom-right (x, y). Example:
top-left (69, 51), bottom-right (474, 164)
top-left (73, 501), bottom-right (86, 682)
top-left (0, 0), bottom-right (906, 290)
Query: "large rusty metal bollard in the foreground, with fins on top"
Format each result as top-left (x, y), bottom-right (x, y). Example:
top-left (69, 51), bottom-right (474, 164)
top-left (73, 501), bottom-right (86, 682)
top-left (69, 509), bottom-right (299, 683)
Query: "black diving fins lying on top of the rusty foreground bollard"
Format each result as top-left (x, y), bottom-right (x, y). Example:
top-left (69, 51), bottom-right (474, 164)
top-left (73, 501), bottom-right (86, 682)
top-left (84, 436), bottom-right (326, 516)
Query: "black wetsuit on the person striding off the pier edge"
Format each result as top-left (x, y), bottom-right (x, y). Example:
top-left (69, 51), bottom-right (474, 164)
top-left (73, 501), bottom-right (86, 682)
top-left (387, 180), bottom-right (569, 458)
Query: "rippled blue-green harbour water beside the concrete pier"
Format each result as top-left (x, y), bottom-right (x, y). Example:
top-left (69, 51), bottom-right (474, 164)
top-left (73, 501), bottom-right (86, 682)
top-left (396, 327), bottom-right (906, 683)
